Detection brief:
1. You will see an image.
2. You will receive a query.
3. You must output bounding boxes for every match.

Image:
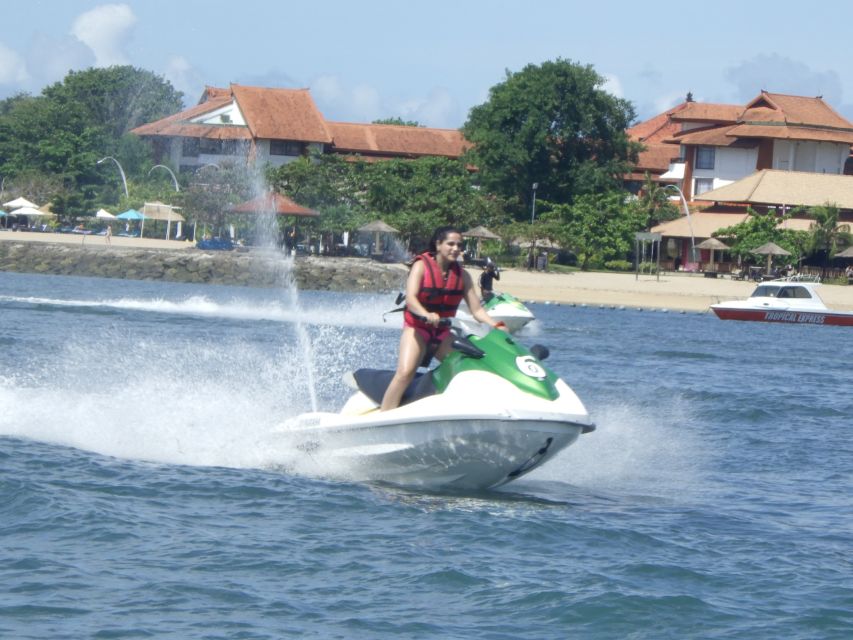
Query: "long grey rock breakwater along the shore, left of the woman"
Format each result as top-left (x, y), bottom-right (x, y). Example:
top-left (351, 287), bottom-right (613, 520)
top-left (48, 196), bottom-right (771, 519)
top-left (0, 241), bottom-right (408, 291)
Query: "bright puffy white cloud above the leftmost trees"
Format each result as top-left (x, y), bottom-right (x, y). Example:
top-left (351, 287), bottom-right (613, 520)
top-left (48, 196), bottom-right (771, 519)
top-left (71, 4), bottom-right (136, 67)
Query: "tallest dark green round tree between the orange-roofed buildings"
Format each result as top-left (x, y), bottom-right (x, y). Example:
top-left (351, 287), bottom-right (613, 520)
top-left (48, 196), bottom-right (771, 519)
top-left (463, 59), bottom-right (640, 219)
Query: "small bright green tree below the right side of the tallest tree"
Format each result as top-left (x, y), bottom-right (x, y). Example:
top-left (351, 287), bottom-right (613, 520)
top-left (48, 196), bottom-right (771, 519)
top-left (552, 191), bottom-right (646, 271)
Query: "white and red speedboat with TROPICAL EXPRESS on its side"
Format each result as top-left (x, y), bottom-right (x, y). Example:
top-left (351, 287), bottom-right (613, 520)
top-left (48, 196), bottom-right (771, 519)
top-left (711, 280), bottom-right (853, 327)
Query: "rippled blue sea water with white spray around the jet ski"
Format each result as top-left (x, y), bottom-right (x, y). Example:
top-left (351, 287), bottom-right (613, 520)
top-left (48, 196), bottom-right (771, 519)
top-left (0, 273), bottom-right (853, 640)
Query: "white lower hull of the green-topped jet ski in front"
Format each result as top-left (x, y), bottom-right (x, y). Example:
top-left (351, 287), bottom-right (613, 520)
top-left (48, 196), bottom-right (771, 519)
top-left (272, 414), bottom-right (592, 490)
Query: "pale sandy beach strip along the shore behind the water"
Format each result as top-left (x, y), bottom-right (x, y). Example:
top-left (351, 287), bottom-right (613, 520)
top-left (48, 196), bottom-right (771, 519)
top-left (5, 232), bottom-right (853, 311)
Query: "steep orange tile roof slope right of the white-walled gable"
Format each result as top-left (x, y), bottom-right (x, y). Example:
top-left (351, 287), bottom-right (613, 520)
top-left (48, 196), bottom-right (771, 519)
top-left (231, 84), bottom-right (332, 144)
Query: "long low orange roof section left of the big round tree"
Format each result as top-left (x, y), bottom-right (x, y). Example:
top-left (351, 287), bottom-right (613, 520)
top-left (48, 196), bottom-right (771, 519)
top-left (327, 122), bottom-right (470, 158)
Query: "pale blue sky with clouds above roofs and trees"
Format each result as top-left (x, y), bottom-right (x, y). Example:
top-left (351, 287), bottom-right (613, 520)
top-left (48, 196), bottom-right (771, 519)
top-left (5, 0), bottom-right (853, 128)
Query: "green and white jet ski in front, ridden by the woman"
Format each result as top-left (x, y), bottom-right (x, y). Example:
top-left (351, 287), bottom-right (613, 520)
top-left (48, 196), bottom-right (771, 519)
top-left (268, 329), bottom-right (595, 490)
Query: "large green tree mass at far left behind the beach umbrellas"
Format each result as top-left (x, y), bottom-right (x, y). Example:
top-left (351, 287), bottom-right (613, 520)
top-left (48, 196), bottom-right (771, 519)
top-left (0, 66), bottom-right (181, 212)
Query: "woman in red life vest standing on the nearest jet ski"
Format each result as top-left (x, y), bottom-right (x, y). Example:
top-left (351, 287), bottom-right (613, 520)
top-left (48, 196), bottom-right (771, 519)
top-left (382, 226), bottom-right (506, 411)
